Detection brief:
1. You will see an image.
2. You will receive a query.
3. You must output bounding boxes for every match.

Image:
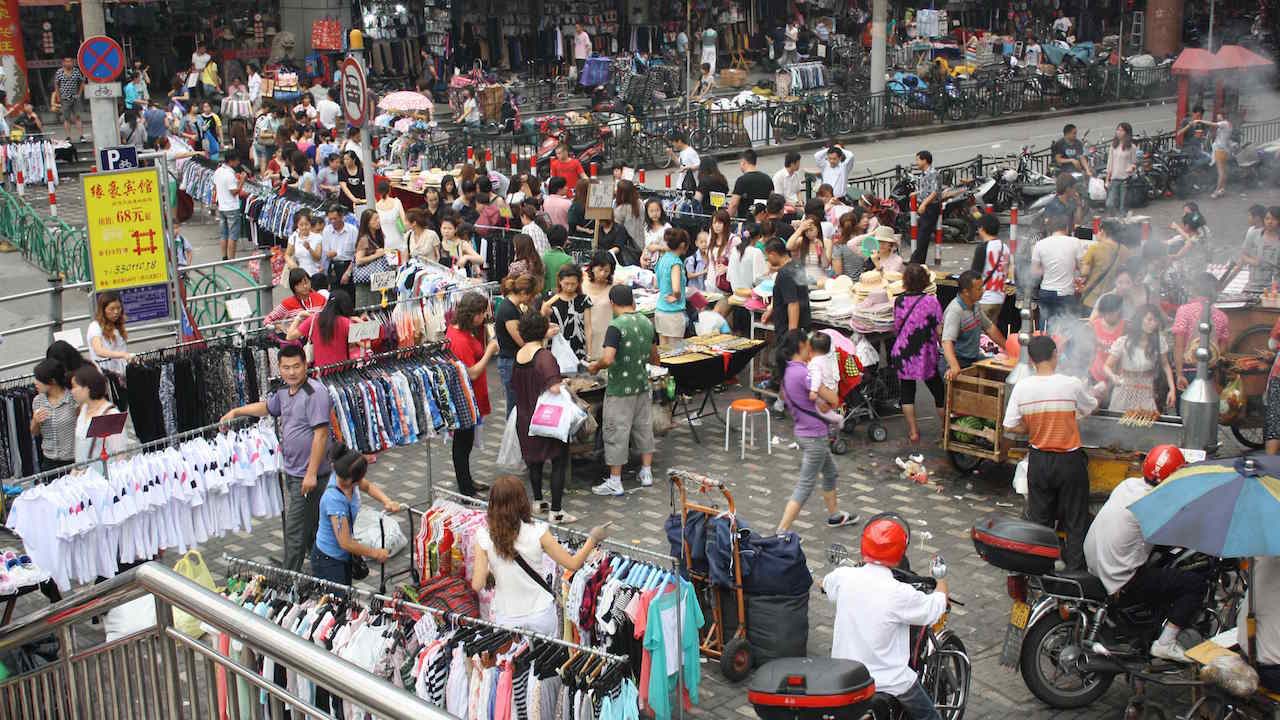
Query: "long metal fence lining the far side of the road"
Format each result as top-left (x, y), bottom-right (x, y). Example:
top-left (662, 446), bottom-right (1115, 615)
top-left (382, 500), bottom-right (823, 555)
top-left (412, 65), bottom-right (1175, 172)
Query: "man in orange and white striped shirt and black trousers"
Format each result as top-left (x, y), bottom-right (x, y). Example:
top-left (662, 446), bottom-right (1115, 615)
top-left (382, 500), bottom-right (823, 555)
top-left (1005, 336), bottom-right (1098, 570)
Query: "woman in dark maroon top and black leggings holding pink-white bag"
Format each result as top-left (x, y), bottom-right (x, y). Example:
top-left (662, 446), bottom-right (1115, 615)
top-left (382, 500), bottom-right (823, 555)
top-left (511, 310), bottom-right (576, 525)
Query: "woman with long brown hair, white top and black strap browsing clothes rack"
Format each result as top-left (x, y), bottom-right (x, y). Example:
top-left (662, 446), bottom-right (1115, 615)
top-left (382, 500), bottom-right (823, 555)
top-left (471, 475), bottom-right (609, 637)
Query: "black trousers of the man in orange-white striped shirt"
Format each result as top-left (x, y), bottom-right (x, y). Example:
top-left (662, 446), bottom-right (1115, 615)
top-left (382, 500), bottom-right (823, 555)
top-left (1027, 448), bottom-right (1089, 570)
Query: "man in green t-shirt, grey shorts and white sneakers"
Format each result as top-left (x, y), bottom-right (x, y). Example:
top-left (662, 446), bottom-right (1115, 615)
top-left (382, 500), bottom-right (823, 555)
top-left (588, 284), bottom-right (658, 496)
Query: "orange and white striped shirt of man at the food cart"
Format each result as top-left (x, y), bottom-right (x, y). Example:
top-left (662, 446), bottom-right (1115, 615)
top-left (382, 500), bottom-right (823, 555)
top-left (1005, 374), bottom-right (1098, 452)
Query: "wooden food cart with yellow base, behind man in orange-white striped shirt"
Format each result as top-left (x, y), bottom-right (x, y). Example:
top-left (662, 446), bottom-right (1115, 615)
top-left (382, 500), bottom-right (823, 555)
top-left (942, 359), bottom-right (1183, 496)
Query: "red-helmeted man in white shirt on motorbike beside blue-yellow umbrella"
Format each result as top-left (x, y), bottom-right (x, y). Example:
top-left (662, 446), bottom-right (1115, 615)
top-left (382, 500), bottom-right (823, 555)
top-left (1084, 445), bottom-right (1206, 662)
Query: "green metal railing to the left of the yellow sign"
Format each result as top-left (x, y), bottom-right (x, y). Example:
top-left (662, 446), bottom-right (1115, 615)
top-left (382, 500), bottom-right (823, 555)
top-left (0, 188), bottom-right (90, 282)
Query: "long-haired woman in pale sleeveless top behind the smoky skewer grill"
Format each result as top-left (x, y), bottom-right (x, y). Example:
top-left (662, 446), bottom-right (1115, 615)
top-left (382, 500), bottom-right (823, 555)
top-left (1106, 305), bottom-right (1176, 413)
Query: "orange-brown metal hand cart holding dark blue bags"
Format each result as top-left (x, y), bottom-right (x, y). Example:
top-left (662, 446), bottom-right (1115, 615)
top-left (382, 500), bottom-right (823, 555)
top-left (667, 468), bottom-right (751, 683)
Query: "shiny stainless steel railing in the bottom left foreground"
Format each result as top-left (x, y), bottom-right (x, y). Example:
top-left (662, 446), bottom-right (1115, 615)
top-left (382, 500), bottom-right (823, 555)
top-left (0, 562), bottom-right (456, 720)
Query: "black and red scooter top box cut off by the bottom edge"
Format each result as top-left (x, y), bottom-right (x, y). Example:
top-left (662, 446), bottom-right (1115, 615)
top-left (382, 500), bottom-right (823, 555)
top-left (746, 657), bottom-right (876, 720)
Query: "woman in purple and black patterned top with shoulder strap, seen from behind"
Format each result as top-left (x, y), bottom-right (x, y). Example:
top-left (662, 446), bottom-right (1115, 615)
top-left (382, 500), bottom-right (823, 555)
top-left (888, 263), bottom-right (946, 442)
